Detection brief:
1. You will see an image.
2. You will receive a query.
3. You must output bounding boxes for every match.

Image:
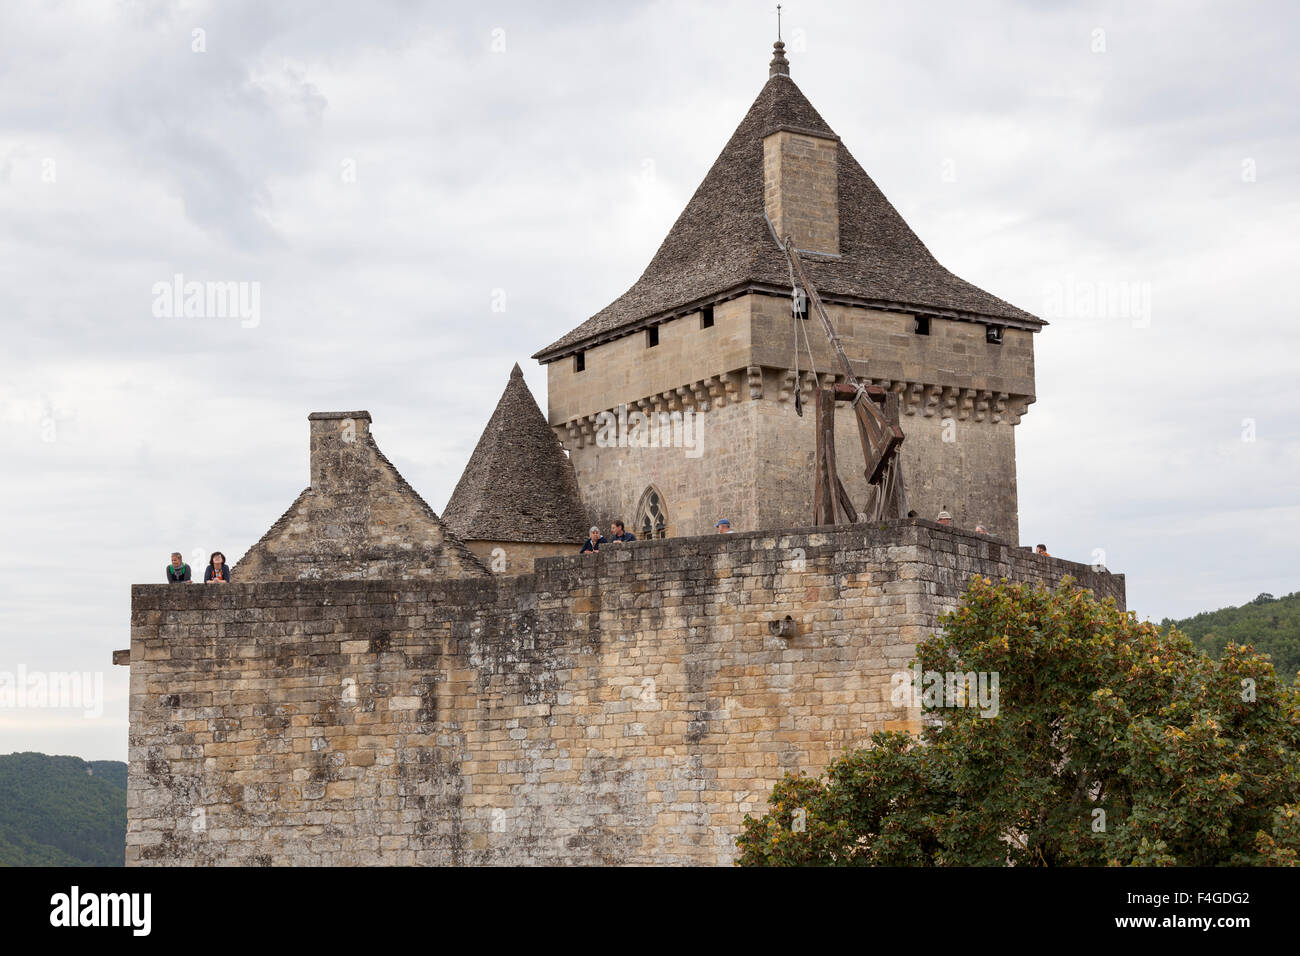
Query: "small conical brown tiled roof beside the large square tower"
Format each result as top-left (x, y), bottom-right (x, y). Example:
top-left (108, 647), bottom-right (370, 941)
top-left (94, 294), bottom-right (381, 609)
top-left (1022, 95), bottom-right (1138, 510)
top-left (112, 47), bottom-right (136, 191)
top-left (442, 363), bottom-right (588, 542)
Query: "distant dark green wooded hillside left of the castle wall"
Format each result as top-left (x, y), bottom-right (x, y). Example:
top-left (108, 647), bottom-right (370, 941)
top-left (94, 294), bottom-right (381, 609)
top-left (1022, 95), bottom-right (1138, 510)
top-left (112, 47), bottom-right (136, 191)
top-left (0, 753), bottom-right (126, 866)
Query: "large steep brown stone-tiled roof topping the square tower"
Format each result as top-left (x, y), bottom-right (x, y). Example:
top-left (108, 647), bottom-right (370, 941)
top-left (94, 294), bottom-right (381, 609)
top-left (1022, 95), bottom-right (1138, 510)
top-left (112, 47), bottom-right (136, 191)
top-left (533, 50), bottom-right (1043, 362)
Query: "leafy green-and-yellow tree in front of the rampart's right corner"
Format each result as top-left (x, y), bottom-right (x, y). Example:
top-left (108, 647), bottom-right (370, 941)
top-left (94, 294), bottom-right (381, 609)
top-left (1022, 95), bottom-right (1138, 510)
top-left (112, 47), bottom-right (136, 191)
top-left (738, 578), bottom-right (1300, 866)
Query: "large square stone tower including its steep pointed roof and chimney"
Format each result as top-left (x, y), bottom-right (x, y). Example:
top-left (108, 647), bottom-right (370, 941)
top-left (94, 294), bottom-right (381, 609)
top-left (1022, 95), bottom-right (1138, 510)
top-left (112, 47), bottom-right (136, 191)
top-left (533, 42), bottom-right (1044, 542)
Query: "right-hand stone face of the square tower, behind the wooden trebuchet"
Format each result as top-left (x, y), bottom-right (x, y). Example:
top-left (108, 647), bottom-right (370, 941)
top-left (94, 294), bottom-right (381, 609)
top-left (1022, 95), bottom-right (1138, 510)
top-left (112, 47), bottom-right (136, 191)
top-left (754, 297), bottom-right (1034, 542)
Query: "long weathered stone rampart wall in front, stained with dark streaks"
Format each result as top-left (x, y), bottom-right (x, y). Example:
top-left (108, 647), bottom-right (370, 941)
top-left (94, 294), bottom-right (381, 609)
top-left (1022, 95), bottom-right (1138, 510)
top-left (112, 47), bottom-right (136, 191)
top-left (126, 522), bottom-right (1125, 865)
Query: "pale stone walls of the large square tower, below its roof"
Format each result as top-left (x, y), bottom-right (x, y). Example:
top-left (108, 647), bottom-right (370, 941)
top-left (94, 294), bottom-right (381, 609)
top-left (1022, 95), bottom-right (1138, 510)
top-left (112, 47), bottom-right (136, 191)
top-left (547, 294), bottom-right (1034, 541)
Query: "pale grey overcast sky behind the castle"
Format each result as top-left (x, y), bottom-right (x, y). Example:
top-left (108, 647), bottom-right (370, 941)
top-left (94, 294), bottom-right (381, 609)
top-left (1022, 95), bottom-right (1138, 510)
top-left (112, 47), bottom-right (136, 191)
top-left (0, 0), bottom-right (1300, 760)
